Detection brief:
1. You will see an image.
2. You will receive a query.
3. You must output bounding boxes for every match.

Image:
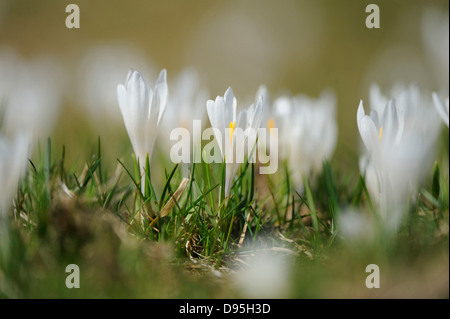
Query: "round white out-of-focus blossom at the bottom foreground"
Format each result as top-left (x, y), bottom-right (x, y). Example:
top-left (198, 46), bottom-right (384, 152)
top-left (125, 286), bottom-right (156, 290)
top-left (233, 251), bottom-right (291, 298)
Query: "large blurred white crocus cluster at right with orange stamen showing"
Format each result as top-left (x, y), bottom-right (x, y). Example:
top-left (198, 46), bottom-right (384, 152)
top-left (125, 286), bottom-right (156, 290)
top-left (357, 85), bottom-right (439, 230)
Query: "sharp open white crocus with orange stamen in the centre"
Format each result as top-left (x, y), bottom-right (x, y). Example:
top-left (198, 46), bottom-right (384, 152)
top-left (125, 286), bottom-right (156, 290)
top-left (206, 88), bottom-right (262, 197)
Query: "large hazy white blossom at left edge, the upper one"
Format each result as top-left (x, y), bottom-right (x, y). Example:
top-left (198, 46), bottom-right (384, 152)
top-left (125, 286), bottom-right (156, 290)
top-left (0, 49), bottom-right (66, 145)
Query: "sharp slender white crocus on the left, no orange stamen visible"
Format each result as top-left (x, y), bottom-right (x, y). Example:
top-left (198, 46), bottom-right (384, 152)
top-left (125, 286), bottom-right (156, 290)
top-left (117, 70), bottom-right (168, 188)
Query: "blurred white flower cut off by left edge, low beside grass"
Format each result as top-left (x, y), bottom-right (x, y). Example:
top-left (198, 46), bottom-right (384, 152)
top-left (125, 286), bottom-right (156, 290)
top-left (0, 134), bottom-right (29, 217)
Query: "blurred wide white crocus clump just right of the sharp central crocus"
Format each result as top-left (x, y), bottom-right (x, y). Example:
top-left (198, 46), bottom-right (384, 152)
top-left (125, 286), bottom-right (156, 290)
top-left (267, 91), bottom-right (337, 192)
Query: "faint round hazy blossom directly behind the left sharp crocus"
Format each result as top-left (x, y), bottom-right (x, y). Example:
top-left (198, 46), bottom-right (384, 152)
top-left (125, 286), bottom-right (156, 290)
top-left (72, 43), bottom-right (157, 127)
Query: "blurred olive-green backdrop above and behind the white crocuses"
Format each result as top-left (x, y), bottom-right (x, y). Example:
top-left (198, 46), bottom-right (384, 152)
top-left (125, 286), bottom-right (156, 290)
top-left (0, 0), bottom-right (449, 172)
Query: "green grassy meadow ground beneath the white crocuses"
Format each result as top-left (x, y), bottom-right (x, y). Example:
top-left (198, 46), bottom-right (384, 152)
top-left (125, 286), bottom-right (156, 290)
top-left (0, 133), bottom-right (449, 298)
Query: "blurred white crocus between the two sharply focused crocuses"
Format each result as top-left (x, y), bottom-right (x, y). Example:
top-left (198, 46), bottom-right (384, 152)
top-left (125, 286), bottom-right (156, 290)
top-left (159, 67), bottom-right (209, 177)
